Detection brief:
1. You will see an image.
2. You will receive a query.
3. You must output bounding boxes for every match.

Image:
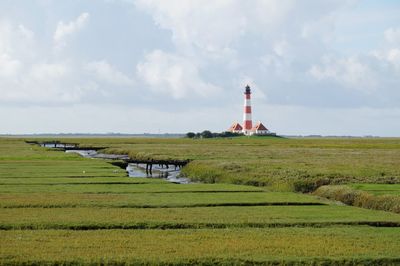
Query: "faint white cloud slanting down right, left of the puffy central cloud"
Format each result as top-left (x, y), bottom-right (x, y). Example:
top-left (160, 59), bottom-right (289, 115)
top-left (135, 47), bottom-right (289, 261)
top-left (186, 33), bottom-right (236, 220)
top-left (85, 60), bottom-right (134, 86)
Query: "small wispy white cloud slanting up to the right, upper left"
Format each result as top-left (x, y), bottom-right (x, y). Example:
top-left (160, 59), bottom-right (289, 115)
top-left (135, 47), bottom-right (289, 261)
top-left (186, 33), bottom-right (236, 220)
top-left (53, 12), bottom-right (89, 49)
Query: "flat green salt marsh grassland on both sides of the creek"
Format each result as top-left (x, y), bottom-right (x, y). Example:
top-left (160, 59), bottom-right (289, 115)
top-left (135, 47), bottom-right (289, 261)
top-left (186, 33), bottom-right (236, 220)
top-left (0, 138), bottom-right (400, 265)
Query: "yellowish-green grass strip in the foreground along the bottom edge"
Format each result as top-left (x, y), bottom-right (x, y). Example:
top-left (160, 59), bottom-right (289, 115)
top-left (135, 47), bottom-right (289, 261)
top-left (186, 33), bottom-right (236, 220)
top-left (0, 226), bottom-right (400, 265)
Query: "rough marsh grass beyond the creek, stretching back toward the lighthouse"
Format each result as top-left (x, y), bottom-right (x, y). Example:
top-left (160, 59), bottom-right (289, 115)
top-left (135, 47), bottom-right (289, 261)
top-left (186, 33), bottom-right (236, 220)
top-left (51, 137), bottom-right (400, 189)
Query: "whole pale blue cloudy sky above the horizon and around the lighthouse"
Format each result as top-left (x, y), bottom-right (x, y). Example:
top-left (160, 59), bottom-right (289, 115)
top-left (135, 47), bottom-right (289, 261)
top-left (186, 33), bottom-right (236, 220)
top-left (0, 0), bottom-right (400, 136)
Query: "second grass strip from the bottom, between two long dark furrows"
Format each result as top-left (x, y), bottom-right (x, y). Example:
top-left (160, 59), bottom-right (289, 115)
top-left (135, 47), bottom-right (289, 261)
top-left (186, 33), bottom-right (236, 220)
top-left (0, 205), bottom-right (400, 230)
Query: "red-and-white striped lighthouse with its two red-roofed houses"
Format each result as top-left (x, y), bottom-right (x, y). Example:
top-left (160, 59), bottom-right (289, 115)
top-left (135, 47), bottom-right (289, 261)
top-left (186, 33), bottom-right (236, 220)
top-left (228, 85), bottom-right (275, 136)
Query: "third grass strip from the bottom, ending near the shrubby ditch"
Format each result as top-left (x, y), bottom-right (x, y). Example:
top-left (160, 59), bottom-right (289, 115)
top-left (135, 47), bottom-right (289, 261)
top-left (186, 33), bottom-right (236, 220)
top-left (0, 191), bottom-right (324, 208)
